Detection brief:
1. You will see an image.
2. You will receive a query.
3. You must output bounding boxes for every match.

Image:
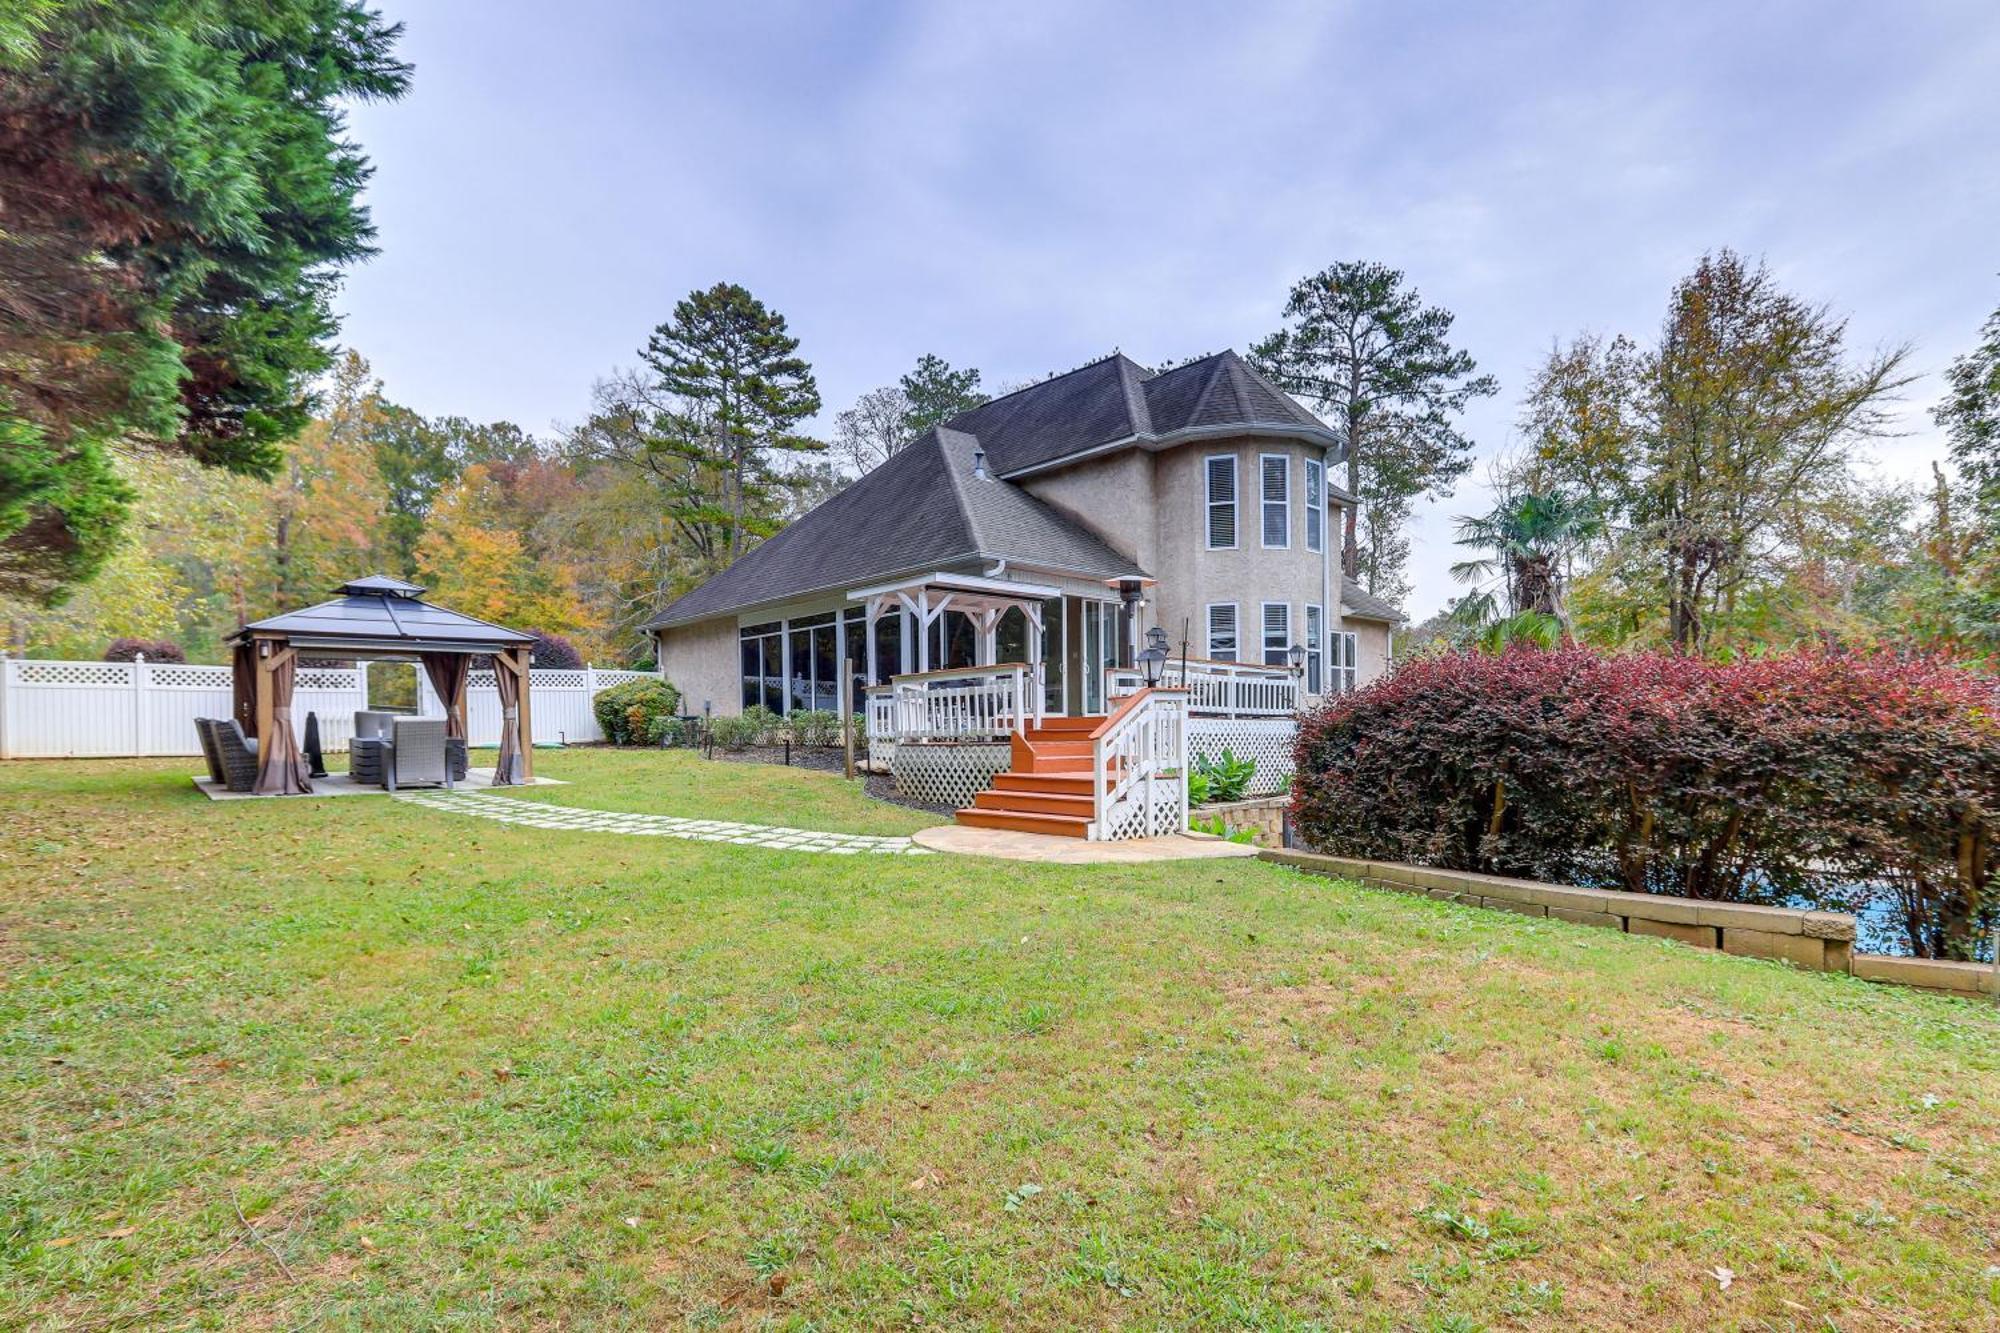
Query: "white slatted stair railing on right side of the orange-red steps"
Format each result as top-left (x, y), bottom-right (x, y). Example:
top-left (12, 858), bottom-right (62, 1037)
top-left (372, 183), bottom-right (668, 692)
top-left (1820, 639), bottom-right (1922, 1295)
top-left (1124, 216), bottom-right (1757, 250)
top-left (1090, 689), bottom-right (1188, 843)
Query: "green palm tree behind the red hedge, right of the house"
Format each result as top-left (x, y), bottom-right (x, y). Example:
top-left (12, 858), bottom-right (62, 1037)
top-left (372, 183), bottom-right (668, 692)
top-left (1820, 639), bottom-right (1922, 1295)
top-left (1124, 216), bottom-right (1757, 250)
top-left (1452, 488), bottom-right (1604, 642)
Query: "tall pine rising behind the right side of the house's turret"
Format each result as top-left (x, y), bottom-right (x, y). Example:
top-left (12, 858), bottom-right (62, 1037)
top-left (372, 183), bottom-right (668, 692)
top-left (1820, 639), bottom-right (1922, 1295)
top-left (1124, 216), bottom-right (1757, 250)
top-left (1250, 262), bottom-right (1498, 592)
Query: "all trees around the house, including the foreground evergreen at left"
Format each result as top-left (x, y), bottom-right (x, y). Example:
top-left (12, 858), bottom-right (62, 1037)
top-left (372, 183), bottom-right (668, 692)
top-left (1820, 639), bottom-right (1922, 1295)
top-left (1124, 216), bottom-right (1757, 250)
top-left (0, 0), bottom-right (2000, 656)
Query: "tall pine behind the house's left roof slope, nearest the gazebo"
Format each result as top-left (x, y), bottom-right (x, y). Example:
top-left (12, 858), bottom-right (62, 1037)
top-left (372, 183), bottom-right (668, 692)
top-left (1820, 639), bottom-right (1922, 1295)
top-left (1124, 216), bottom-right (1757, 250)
top-left (640, 282), bottom-right (826, 558)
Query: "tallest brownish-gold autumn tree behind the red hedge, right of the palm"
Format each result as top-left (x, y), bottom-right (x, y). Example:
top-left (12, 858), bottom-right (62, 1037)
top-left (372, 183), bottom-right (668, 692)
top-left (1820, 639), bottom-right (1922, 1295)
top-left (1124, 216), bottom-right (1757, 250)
top-left (1522, 250), bottom-right (1908, 652)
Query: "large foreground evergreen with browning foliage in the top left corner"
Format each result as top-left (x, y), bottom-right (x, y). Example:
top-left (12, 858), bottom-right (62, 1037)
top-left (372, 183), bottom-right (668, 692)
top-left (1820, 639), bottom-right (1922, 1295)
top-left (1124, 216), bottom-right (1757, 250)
top-left (0, 0), bottom-right (408, 600)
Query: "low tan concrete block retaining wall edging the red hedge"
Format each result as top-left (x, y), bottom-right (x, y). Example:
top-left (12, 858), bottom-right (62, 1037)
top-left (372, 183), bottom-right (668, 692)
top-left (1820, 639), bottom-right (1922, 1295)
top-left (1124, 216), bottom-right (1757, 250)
top-left (1258, 849), bottom-right (2000, 997)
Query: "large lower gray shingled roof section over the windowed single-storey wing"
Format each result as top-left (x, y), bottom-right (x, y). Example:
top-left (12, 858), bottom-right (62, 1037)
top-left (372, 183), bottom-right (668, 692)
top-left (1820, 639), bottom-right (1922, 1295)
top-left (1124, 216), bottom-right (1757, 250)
top-left (646, 426), bottom-right (1142, 628)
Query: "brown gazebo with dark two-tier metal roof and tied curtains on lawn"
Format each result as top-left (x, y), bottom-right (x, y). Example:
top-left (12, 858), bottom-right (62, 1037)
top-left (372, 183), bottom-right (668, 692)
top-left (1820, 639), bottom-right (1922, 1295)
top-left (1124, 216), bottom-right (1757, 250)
top-left (230, 574), bottom-right (534, 795)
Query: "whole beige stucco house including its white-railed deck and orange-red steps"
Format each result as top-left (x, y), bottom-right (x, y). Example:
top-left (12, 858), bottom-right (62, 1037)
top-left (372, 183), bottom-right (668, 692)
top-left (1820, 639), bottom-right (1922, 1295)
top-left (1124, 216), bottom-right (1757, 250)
top-left (648, 352), bottom-right (1402, 839)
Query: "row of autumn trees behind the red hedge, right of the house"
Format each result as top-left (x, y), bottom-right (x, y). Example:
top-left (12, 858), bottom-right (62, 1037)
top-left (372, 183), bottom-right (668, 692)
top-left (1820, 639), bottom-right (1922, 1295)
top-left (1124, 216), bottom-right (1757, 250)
top-left (1426, 250), bottom-right (2000, 656)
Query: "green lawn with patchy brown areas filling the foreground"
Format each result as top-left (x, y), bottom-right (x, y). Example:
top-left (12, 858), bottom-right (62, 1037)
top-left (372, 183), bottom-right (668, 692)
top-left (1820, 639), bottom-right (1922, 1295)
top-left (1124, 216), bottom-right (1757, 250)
top-left (0, 751), bottom-right (2000, 1329)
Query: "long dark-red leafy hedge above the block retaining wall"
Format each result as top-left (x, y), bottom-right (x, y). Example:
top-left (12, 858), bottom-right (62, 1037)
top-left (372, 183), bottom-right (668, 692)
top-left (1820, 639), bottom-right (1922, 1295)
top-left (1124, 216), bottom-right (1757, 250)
top-left (1292, 648), bottom-right (2000, 957)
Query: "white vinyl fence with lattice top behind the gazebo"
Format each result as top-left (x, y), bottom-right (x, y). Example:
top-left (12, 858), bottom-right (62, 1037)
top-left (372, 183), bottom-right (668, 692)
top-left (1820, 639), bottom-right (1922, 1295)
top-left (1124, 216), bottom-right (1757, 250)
top-left (0, 656), bottom-right (660, 759)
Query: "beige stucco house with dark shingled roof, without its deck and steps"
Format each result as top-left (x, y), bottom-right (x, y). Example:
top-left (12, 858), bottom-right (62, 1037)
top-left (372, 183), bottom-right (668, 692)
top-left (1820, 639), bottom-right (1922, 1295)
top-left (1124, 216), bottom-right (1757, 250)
top-left (648, 352), bottom-right (1402, 715)
